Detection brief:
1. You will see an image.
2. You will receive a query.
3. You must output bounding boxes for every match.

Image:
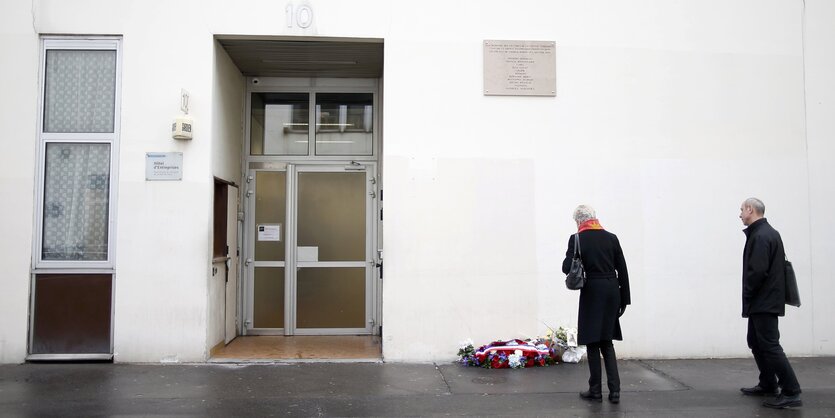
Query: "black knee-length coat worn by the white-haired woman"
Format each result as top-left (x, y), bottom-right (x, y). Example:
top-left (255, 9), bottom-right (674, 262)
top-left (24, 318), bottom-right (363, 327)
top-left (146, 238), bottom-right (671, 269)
top-left (562, 229), bottom-right (631, 345)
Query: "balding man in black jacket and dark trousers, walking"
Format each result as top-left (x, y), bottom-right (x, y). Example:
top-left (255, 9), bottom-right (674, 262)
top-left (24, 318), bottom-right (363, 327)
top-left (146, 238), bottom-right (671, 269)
top-left (739, 198), bottom-right (803, 409)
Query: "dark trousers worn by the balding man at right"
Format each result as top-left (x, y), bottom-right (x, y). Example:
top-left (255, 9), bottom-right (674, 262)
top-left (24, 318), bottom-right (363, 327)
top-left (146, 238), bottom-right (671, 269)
top-left (748, 314), bottom-right (800, 396)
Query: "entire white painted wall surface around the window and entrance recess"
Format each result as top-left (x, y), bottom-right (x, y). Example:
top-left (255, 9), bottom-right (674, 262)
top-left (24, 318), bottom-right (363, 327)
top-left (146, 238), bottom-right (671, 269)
top-left (0, 0), bottom-right (835, 362)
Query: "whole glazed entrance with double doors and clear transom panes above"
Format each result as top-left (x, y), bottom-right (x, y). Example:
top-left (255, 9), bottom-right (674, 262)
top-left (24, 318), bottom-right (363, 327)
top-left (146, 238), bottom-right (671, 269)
top-left (240, 77), bottom-right (382, 343)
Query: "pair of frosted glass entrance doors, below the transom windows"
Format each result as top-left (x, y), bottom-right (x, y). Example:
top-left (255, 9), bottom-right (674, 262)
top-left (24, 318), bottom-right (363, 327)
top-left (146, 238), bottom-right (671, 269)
top-left (244, 162), bottom-right (379, 335)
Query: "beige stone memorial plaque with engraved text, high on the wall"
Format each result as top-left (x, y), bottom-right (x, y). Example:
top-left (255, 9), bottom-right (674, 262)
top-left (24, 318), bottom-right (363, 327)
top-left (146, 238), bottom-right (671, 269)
top-left (484, 40), bottom-right (557, 96)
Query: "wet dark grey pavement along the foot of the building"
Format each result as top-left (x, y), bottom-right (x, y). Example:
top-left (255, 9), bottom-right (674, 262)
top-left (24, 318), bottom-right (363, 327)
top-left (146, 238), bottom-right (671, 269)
top-left (0, 357), bottom-right (835, 417)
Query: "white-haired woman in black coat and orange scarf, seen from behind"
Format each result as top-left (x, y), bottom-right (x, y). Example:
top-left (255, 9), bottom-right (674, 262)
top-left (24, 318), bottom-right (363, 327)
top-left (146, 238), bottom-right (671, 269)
top-left (562, 205), bottom-right (630, 403)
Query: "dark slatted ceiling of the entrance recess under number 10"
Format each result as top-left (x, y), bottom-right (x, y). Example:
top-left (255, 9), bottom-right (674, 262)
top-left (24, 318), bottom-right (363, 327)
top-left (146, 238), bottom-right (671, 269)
top-left (218, 38), bottom-right (383, 78)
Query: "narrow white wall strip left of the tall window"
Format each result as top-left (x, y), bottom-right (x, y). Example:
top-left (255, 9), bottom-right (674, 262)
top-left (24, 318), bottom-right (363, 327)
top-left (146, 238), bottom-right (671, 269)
top-left (0, 2), bottom-right (38, 363)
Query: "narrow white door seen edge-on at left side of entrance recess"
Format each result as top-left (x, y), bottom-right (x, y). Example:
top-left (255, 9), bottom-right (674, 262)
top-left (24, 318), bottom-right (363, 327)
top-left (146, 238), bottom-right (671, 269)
top-left (224, 185), bottom-right (240, 344)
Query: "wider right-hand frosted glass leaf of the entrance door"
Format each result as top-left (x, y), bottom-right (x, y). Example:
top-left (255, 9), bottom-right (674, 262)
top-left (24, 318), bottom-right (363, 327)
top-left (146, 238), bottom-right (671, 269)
top-left (294, 165), bottom-right (375, 334)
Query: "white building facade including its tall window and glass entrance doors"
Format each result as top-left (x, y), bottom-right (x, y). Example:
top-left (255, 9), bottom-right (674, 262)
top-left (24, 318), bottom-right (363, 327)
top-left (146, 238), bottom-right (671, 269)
top-left (0, 0), bottom-right (835, 363)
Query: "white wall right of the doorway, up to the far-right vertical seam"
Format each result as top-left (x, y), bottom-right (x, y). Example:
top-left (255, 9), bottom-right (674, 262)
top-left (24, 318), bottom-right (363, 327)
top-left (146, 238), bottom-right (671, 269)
top-left (383, 1), bottom-right (820, 360)
